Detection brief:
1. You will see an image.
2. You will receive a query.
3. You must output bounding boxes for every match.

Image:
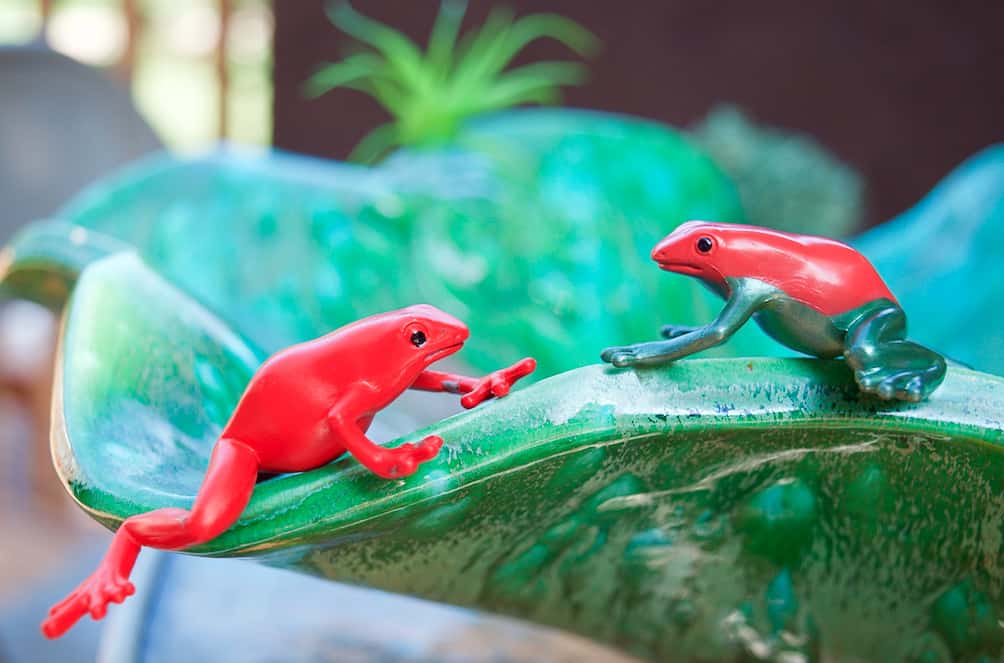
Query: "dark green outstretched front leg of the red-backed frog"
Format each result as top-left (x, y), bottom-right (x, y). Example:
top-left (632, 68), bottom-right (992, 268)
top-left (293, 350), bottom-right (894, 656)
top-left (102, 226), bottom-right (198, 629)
top-left (599, 279), bottom-right (777, 368)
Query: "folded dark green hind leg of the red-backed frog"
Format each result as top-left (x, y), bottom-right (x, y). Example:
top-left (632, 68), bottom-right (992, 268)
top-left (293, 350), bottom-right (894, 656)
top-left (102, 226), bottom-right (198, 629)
top-left (843, 302), bottom-right (946, 402)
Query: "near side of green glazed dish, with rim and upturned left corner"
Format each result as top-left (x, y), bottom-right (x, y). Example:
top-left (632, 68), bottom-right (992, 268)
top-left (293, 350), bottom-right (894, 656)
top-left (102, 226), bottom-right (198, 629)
top-left (53, 253), bottom-right (1004, 661)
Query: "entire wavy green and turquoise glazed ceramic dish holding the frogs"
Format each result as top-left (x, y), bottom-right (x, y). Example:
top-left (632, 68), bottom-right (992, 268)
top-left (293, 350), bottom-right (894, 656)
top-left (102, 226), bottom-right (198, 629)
top-left (3, 112), bottom-right (1004, 661)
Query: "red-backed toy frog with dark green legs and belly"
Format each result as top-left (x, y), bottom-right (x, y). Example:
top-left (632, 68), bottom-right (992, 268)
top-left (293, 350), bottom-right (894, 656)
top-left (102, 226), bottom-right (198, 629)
top-left (601, 221), bottom-right (946, 401)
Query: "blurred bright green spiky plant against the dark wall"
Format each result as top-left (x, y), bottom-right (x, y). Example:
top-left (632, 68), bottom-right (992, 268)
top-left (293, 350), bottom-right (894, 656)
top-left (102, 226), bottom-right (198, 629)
top-left (307, 0), bottom-right (599, 163)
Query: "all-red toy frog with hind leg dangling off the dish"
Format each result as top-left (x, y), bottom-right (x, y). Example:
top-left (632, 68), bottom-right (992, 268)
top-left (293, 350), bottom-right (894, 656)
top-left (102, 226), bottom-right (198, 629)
top-left (42, 305), bottom-right (536, 638)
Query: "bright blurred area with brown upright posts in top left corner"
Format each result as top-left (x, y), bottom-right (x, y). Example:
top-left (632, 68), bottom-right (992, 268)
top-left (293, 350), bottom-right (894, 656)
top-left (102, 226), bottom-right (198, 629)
top-left (0, 0), bottom-right (273, 152)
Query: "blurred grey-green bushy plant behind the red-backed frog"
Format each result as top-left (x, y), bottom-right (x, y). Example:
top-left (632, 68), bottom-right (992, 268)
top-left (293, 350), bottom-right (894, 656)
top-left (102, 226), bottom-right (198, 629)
top-left (691, 105), bottom-right (864, 237)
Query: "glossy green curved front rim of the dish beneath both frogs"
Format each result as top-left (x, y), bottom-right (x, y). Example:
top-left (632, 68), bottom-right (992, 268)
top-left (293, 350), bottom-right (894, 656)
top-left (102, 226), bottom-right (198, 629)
top-left (51, 359), bottom-right (1004, 557)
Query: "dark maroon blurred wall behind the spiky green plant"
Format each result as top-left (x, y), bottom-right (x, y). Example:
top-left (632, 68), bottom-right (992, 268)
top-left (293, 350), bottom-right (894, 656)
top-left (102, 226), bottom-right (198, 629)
top-left (273, 0), bottom-right (1004, 225)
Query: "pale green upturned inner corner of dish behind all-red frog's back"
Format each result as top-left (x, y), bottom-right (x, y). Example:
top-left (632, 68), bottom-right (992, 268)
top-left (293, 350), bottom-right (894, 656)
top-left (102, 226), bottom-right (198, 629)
top-left (52, 252), bottom-right (266, 522)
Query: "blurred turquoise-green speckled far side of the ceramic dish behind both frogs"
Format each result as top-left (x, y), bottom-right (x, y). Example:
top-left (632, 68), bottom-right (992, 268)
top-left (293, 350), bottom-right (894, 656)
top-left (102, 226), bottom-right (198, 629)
top-left (1, 109), bottom-right (778, 377)
